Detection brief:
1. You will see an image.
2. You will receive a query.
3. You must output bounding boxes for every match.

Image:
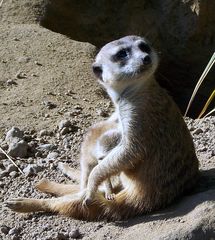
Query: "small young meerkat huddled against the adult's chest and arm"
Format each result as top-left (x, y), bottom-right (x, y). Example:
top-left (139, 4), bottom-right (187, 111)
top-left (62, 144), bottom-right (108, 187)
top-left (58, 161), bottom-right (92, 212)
top-left (58, 114), bottom-right (121, 200)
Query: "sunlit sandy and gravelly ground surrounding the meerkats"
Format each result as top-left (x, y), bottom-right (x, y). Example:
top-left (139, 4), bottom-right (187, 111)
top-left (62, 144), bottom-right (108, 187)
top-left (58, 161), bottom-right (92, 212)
top-left (0, 24), bottom-right (215, 240)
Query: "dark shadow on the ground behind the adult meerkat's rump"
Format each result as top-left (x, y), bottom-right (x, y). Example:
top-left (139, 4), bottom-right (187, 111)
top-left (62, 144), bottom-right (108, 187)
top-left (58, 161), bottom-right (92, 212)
top-left (115, 168), bottom-right (215, 228)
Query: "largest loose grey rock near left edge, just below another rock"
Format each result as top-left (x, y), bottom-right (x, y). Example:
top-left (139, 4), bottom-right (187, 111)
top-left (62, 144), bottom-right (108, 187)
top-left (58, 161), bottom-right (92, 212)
top-left (8, 140), bottom-right (28, 158)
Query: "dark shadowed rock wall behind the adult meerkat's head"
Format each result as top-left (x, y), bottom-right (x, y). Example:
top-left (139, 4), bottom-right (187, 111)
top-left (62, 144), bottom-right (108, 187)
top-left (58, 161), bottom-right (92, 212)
top-left (0, 0), bottom-right (215, 117)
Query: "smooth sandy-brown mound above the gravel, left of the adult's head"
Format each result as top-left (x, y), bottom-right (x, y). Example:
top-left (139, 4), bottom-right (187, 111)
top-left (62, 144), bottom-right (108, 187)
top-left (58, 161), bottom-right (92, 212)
top-left (0, 24), bottom-right (96, 130)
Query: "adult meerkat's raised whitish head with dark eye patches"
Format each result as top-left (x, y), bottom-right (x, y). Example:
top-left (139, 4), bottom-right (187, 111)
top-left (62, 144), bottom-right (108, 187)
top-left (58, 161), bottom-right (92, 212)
top-left (93, 36), bottom-right (158, 90)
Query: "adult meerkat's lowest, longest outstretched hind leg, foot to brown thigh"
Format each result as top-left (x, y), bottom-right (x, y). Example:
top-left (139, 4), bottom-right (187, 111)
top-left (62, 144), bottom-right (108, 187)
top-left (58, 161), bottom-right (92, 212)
top-left (5, 190), bottom-right (141, 220)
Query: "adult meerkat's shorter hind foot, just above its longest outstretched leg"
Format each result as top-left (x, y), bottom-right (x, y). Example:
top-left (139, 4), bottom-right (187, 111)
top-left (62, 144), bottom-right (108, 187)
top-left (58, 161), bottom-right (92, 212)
top-left (36, 179), bottom-right (79, 196)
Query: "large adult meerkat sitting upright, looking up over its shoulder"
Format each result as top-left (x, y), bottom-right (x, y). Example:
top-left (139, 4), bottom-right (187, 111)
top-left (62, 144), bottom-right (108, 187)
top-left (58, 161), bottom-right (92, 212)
top-left (6, 36), bottom-right (199, 220)
